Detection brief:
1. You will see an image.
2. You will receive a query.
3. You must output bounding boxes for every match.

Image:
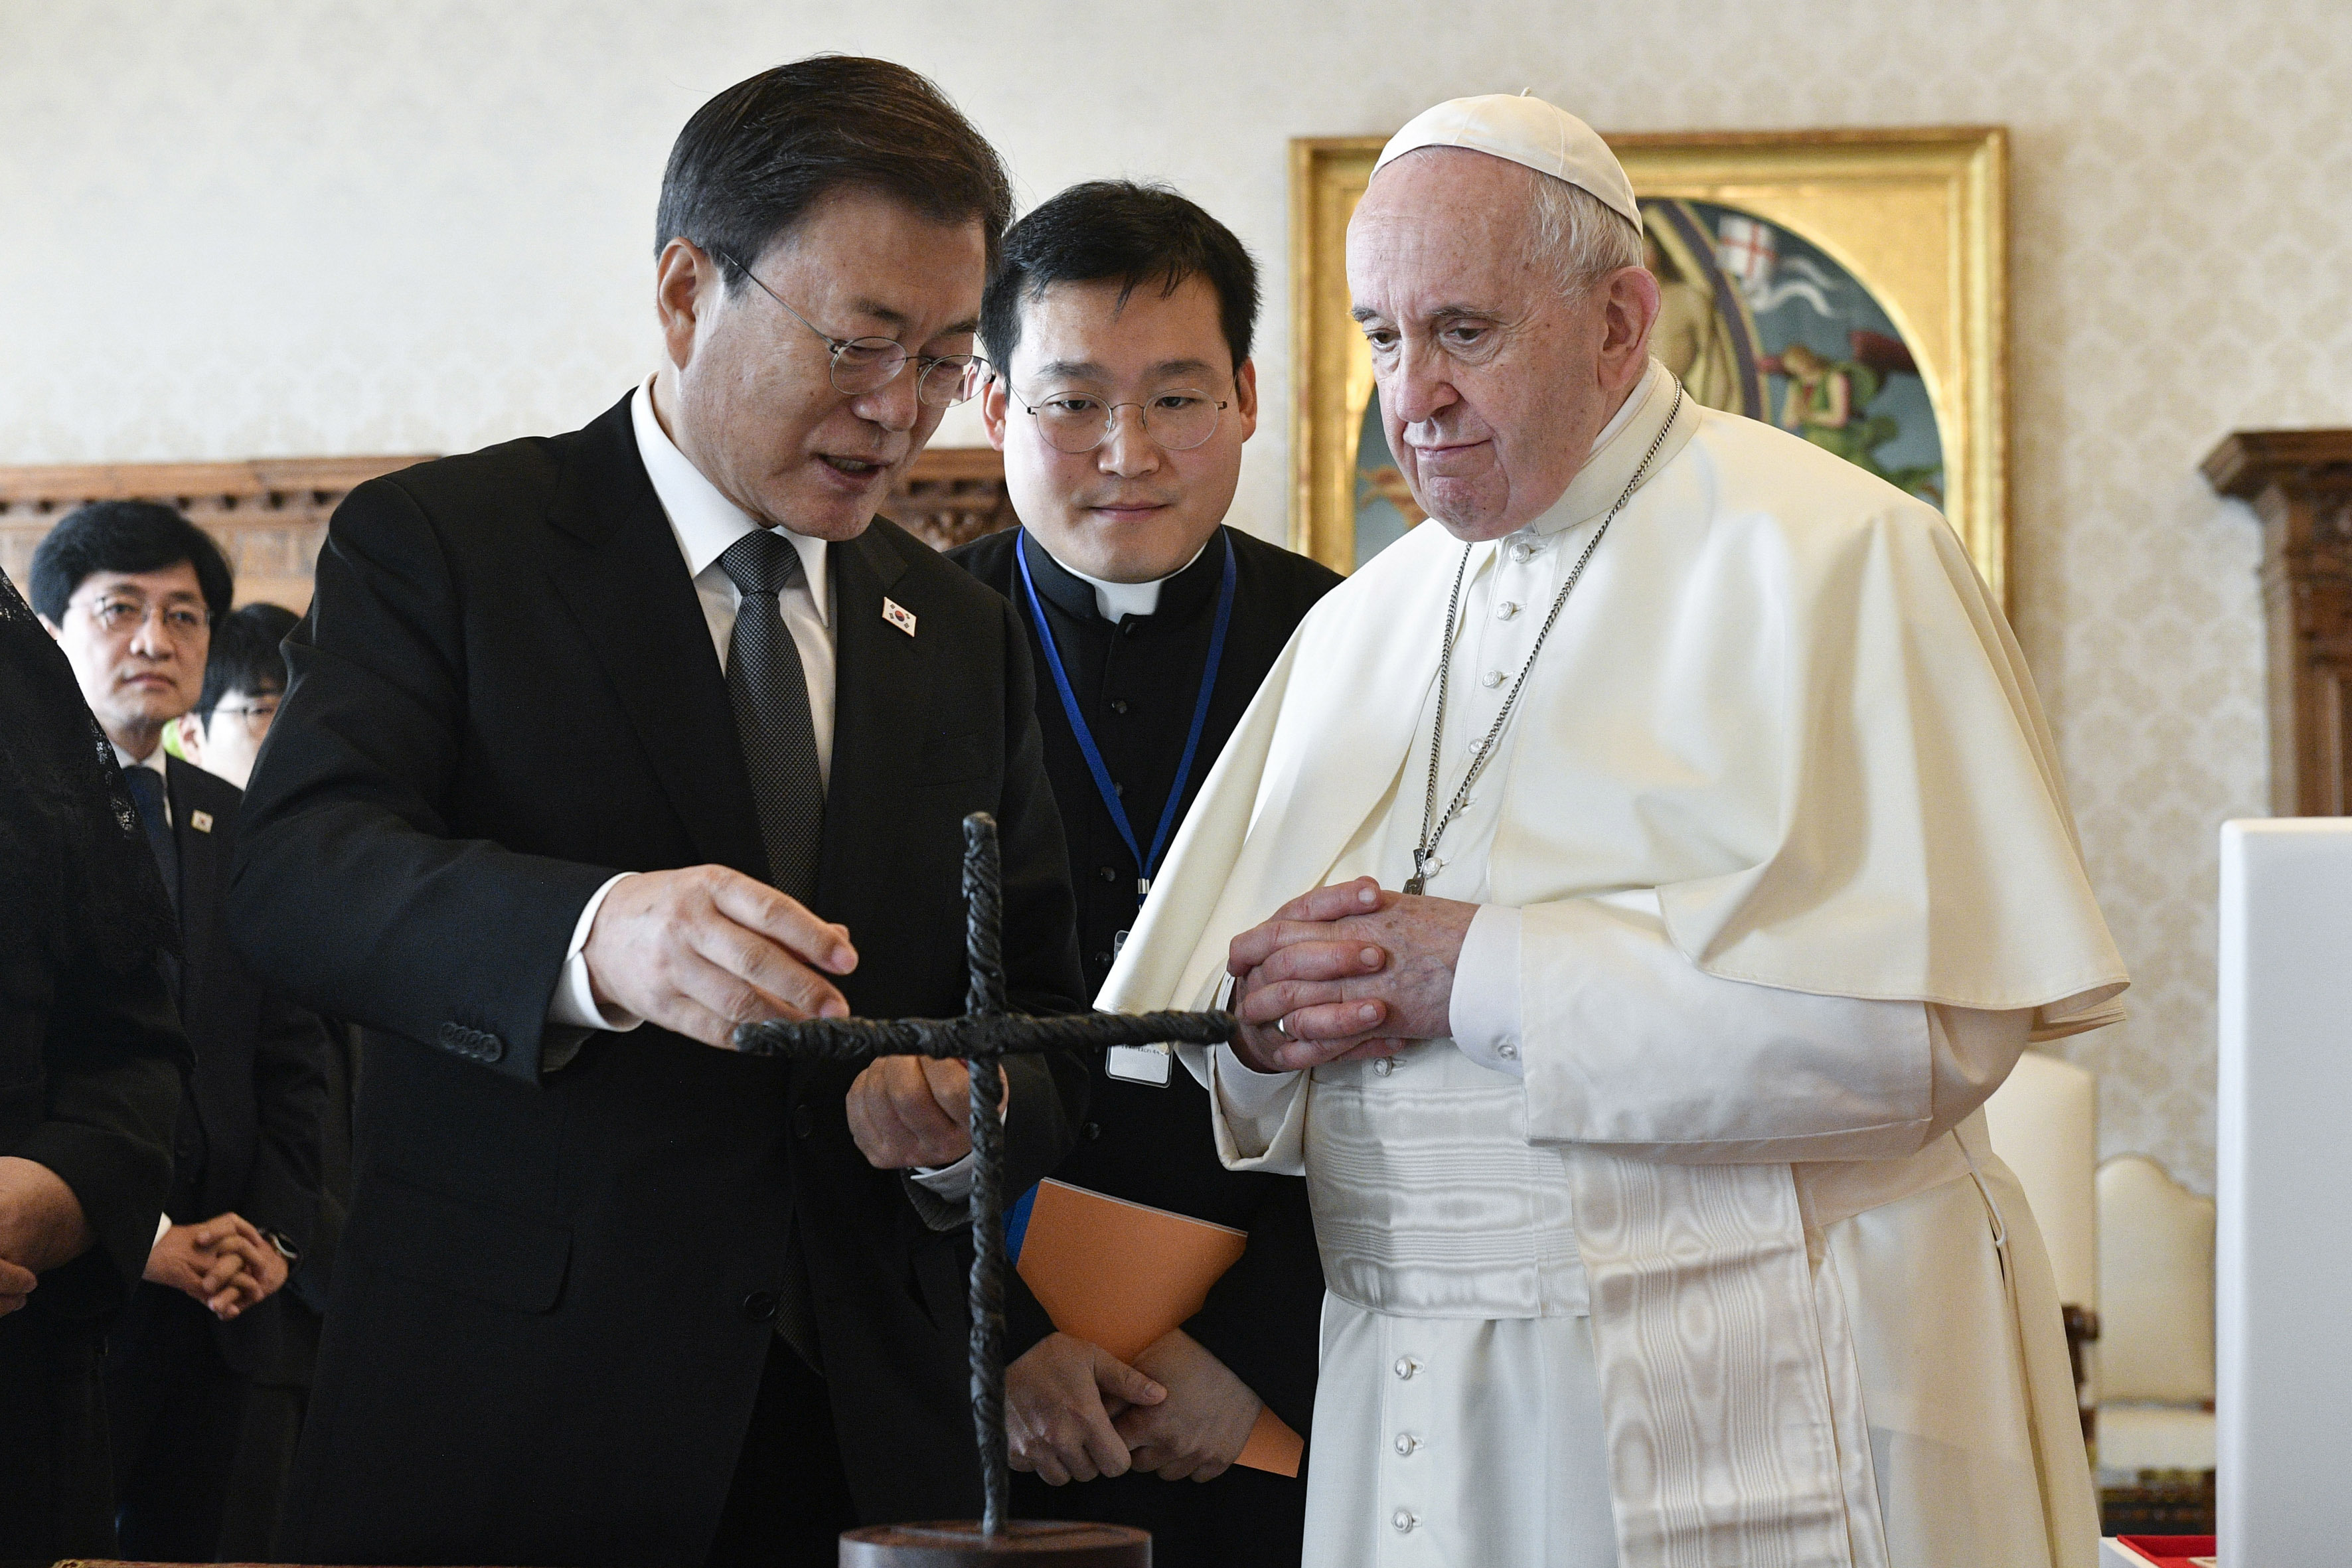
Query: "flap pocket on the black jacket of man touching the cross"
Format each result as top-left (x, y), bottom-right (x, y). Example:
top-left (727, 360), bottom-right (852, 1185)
top-left (362, 1173), bottom-right (572, 1312)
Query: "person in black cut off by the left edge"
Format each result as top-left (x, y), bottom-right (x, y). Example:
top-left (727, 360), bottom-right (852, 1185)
top-left (0, 562), bottom-right (188, 1556)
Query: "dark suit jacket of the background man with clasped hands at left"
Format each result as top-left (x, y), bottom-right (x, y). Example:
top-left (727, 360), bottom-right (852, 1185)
top-left (118, 757), bottom-right (327, 1377)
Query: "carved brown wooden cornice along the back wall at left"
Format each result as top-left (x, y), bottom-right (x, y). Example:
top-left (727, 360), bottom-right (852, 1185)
top-left (0, 447), bottom-right (1014, 611)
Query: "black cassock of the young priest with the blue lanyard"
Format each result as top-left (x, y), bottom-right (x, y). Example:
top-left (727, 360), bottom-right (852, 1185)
top-left (953, 529), bottom-right (1341, 1568)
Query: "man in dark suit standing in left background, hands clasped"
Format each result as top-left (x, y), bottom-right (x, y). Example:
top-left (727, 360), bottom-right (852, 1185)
top-left (33, 501), bottom-right (327, 1561)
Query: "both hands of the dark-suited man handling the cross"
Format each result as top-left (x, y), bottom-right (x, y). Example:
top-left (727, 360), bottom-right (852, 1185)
top-left (581, 865), bottom-right (971, 1171)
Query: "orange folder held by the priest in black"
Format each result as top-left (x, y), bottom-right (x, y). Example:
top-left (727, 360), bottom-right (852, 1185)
top-left (1018, 1180), bottom-right (1305, 1476)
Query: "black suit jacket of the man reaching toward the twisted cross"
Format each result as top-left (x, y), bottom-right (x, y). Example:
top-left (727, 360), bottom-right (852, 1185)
top-left (233, 400), bottom-right (1084, 1565)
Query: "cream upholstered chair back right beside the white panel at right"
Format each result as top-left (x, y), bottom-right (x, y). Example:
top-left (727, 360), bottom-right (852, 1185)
top-left (2098, 1154), bottom-right (2213, 1474)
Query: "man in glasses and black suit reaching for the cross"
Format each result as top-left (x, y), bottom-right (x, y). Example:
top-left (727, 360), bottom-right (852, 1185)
top-left (233, 56), bottom-right (1084, 1565)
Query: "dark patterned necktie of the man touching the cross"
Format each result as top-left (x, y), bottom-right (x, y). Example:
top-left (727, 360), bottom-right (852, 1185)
top-left (720, 529), bottom-right (826, 903)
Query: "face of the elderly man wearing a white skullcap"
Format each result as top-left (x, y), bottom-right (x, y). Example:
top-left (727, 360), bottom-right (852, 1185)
top-left (1348, 148), bottom-right (1658, 540)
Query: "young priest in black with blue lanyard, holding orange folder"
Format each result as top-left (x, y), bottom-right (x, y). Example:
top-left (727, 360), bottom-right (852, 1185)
top-left (955, 181), bottom-right (1338, 1568)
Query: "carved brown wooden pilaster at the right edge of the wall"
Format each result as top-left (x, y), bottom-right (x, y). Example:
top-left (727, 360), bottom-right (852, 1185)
top-left (2204, 430), bottom-right (2352, 816)
